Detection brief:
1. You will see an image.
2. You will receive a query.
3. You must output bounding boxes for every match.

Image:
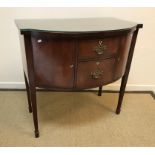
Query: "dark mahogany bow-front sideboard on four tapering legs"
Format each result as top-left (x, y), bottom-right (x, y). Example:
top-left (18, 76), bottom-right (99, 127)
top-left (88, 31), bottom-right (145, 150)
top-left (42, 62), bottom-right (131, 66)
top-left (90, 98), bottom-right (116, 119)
top-left (15, 18), bottom-right (143, 137)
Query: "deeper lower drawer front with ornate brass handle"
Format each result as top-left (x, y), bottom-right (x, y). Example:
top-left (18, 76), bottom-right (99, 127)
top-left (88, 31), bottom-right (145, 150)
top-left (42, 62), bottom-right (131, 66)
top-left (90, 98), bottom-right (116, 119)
top-left (76, 59), bottom-right (115, 88)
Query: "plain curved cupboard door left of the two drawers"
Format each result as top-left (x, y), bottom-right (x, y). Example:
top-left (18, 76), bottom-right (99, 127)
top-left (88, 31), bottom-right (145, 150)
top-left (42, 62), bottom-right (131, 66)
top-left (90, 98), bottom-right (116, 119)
top-left (32, 38), bottom-right (74, 88)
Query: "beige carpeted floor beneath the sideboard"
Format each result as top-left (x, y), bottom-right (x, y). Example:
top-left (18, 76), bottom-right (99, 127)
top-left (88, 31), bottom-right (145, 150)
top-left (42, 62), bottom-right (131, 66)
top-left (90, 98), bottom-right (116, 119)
top-left (0, 91), bottom-right (155, 146)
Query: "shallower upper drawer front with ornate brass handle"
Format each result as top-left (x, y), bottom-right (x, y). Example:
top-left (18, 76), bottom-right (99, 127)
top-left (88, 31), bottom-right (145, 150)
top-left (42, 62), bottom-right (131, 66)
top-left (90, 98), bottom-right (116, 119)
top-left (78, 37), bottom-right (120, 59)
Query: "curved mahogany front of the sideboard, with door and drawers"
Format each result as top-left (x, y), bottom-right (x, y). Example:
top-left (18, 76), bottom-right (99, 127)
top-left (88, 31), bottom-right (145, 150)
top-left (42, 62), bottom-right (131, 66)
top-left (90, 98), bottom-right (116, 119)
top-left (31, 29), bottom-right (133, 89)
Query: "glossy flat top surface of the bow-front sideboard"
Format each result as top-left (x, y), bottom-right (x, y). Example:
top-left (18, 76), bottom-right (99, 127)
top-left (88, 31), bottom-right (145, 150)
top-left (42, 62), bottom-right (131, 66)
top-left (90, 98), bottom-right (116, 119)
top-left (15, 18), bottom-right (139, 32)
